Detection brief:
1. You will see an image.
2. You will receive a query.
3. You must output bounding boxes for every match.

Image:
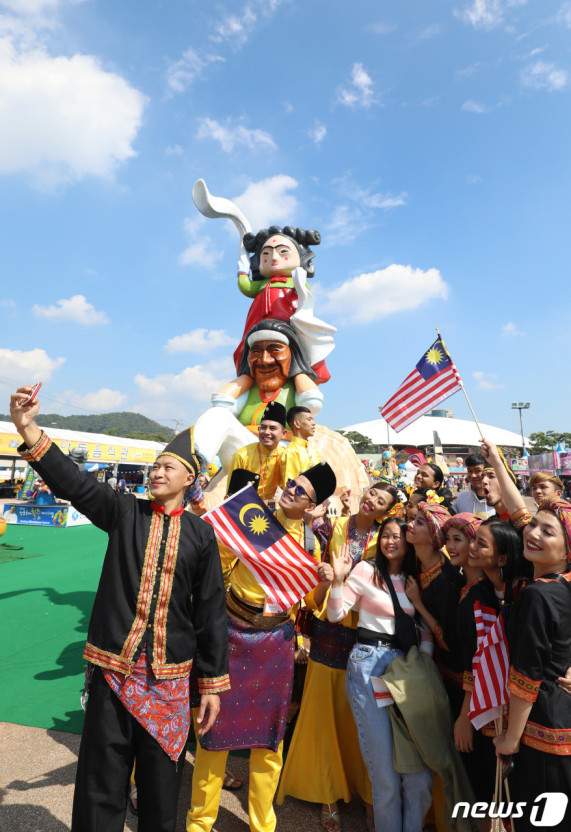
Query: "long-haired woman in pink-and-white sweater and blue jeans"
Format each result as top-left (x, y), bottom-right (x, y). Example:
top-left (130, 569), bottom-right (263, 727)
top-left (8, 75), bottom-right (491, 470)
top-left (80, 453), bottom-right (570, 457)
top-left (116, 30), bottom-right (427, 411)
top-left (327, 517), bottom-right (432, 832)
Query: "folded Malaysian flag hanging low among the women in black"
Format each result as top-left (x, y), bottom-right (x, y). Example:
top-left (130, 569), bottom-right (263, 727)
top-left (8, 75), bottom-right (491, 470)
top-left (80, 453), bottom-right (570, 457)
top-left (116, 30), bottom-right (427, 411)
top-left (468, 602), bottom-right (510, 729)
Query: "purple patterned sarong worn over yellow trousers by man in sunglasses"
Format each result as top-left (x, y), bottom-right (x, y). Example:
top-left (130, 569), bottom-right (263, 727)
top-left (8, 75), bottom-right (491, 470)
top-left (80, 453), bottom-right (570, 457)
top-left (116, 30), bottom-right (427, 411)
top-left (200, 616), bottom-right (295, 751)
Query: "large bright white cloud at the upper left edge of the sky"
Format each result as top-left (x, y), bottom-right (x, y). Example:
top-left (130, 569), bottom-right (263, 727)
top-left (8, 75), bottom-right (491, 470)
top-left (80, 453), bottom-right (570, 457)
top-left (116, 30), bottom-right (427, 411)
top-left (0, 37), bottom-right (146, 187)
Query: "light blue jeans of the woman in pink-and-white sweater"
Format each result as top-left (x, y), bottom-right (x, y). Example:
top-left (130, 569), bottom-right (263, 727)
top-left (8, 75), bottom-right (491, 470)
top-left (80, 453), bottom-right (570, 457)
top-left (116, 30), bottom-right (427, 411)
top-left (345, 643), bottom-right (432, 832)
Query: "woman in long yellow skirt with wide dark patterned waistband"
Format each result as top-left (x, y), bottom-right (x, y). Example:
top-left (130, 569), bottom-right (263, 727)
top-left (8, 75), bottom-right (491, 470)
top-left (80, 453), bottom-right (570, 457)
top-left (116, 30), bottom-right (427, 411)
top-left (278, 482), bottom-right (398, 832)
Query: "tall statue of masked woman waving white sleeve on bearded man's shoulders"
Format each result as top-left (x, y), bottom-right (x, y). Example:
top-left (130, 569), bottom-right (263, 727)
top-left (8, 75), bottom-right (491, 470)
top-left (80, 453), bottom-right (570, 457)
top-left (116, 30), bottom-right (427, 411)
top-left (192, 179), bottom-right (368, 505)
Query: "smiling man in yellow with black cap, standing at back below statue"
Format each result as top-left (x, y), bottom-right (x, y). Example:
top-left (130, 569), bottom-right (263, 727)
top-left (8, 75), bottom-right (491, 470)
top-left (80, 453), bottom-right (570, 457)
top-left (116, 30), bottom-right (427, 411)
top-left (228, 402), bottom-right (286, 503)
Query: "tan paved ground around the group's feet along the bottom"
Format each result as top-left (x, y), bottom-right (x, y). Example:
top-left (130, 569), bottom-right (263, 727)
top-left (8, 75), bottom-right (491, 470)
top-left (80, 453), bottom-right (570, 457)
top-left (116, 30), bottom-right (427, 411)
top-left (0, 722), bottom-right (365, 832)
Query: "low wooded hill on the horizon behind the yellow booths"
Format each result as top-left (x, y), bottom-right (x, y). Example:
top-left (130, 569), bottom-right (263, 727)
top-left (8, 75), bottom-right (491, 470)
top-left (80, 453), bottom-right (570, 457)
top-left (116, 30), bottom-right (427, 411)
top-left (0, 412), bottom-right (173, 442)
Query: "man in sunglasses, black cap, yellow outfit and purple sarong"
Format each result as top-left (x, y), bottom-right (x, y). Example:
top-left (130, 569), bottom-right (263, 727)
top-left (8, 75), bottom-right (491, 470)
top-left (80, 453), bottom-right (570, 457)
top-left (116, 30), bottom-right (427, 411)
top-left (186, 462), bottom-right (336, 832)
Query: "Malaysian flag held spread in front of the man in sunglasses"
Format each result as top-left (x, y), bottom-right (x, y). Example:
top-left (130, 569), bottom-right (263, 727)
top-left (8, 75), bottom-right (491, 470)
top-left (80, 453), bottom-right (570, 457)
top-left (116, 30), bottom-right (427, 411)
top-left (202, 485), bottom-right (319, 614)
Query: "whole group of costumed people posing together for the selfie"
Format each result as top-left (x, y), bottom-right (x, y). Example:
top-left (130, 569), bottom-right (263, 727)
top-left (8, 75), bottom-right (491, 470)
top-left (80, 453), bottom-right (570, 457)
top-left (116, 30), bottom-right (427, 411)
top-left (11, 387), bottom-right (571, 832)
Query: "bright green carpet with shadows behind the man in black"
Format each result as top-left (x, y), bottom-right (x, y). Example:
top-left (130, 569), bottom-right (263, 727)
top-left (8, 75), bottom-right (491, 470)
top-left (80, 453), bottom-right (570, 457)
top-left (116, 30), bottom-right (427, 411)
top-left (0, 526), bottom-right (107, 733)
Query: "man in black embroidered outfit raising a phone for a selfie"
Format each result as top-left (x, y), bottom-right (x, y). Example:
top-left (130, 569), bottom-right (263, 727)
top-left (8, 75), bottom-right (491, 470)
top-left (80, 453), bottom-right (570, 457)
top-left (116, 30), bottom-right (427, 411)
top-left (10, 387), bottom-right (230, 832)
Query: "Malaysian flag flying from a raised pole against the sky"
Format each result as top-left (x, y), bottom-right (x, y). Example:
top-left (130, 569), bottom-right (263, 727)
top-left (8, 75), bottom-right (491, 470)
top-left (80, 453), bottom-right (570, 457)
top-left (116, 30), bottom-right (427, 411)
top-left (381, 335), bottom-right (463, 433)
